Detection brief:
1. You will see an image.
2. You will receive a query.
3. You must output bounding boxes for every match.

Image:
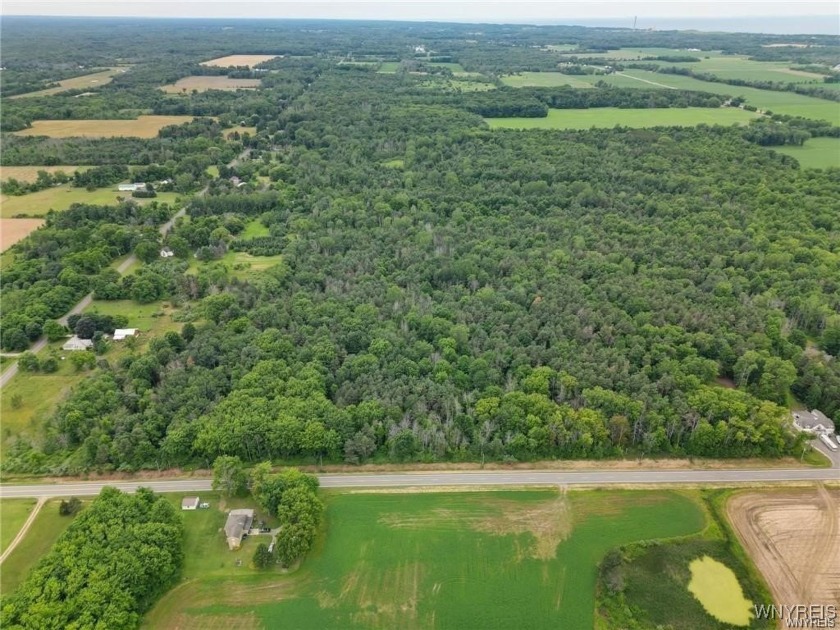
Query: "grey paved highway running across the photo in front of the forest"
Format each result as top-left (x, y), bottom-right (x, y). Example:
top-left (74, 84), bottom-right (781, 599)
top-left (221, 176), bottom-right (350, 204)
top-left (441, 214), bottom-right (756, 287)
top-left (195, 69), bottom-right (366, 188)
top-left (0, 468), bottom-right (840, 498)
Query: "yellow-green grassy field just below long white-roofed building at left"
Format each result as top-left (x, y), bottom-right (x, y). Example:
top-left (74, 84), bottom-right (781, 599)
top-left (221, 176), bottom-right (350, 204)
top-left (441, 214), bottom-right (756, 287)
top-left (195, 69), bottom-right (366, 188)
top-left (0, 184), bottom-right (178, 219)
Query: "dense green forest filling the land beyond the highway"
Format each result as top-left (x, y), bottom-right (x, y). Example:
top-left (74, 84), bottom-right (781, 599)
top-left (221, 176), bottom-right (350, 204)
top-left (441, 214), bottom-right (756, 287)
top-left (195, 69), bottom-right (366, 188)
top-left (2, 18), bottom-right (840, 474)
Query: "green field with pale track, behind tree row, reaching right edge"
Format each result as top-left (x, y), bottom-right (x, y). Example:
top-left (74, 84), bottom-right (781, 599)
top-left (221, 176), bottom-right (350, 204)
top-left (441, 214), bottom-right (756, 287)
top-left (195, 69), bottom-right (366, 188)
top-left (590, 70), bottom-right (840, 125)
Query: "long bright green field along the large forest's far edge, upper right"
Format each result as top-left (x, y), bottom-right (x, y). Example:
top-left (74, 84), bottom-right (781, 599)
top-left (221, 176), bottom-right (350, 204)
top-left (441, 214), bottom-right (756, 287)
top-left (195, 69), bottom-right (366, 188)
top-left (484, 107), bottom-right (755, 129)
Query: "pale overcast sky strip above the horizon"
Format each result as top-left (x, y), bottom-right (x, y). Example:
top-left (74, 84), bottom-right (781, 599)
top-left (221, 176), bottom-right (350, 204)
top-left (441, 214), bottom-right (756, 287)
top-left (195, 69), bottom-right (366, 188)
top-left (0, 0), bottom-right (840, 23)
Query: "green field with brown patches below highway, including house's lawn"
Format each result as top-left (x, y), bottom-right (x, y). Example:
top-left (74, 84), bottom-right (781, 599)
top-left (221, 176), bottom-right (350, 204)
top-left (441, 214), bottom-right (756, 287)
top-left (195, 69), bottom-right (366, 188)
top-left (145, 490), bottom-right (705, 630)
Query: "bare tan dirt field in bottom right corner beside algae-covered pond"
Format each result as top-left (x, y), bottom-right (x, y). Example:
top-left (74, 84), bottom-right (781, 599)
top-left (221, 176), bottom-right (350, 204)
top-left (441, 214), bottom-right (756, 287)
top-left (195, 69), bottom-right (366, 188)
top-left (727, 486), bottom-right (840, 624)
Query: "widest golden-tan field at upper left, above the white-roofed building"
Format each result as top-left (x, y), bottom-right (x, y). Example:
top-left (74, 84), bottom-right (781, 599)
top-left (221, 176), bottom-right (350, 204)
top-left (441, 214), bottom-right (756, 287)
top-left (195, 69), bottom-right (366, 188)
top-left (15, 116), bottom-right (194, 138)
